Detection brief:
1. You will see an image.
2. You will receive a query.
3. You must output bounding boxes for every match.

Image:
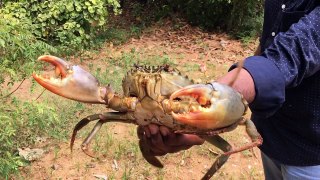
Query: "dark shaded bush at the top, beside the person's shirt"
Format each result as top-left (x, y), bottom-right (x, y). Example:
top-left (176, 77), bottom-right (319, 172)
top-left (154, 0), bottom-right (263, 38)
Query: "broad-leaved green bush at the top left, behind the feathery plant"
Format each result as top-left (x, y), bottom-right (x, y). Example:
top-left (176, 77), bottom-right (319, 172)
top-left (0, 0), bottom-right (120, 48)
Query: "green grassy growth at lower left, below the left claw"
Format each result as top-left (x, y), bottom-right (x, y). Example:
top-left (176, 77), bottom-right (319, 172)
top-left (0, 86), bottom-right (90, 178)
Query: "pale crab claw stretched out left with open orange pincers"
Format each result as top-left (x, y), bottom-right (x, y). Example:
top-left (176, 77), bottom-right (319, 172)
top-left (32, 55), bottom-right (105, 104)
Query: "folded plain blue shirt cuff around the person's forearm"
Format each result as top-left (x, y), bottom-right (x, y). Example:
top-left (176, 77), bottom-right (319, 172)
top-left (230, 56), bottom-right (285, 118)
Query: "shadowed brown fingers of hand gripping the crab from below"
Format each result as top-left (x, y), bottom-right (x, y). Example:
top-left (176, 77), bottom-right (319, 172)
top-left (137, 124), bottom-right (204, 156)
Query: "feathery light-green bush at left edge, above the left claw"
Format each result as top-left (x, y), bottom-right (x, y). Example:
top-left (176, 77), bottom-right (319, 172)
top-left (0, 13), bottom-right (56, 83)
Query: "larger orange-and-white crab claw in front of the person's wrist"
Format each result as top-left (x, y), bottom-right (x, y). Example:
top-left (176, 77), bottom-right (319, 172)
top-left (170, 82), bottom-right (246, 129)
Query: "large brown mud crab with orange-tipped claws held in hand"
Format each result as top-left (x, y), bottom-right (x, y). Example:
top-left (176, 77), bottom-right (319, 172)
top-left (33, 55), bottom-right (262, 179)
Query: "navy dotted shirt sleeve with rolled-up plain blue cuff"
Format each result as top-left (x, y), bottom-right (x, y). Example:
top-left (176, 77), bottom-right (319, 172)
top-left (232, 7), bottom-right (320, 118)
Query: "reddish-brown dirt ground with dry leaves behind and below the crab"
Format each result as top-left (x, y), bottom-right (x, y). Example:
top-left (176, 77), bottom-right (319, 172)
top-left (15, 21), bottom-right (264, 180)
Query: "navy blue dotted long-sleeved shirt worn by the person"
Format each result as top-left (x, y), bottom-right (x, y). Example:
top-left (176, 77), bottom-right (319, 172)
top-left (244, 0), bottom-right (320, 166)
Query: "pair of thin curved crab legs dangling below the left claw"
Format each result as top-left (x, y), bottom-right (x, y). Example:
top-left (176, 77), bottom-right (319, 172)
top-left (70, 112), bottom-right (135, 157)
